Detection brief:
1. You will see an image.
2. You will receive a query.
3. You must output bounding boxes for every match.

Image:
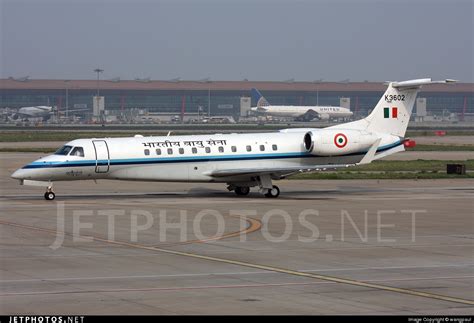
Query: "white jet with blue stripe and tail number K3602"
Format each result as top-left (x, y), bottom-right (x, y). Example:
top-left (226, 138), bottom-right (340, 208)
top-left (11, 79), bottom-right (455, 200)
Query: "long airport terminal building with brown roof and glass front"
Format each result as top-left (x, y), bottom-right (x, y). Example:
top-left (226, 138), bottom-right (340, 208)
top-left (0, 78), bottom-right (474, 121)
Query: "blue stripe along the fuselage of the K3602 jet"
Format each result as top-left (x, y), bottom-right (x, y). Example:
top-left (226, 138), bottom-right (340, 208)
top-left (23, 141), bottom-right (402, 169)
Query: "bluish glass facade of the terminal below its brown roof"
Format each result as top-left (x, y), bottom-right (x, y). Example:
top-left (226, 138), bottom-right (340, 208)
top-left (0, 89), bottom-right (474, 117)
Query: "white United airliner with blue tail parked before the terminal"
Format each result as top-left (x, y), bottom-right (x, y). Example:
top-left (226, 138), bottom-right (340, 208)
top-left (250, 88), bottom-right (352, 121)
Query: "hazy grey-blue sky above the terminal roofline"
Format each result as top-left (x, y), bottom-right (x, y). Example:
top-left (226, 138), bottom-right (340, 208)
top-left (0, 0), bottom-right (474, 82)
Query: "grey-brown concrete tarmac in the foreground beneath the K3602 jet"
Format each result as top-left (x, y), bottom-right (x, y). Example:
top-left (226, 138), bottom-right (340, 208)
top-left (0, 153), bottom-right (474, 315)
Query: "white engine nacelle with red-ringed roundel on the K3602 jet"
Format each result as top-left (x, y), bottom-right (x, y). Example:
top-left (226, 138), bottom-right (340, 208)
top-left (304, 129), bottom-right (377, 156)
